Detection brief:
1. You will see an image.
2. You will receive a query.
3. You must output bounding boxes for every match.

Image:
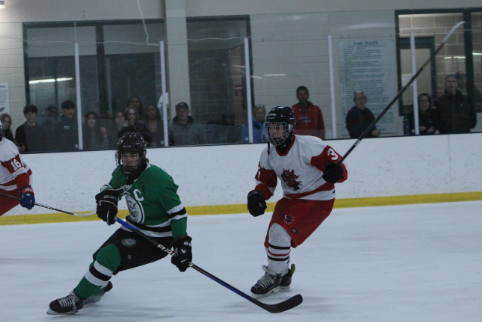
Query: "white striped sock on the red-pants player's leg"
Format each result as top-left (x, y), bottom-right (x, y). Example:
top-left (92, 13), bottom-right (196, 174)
top-left (266, 224), bottom-right (292, 275)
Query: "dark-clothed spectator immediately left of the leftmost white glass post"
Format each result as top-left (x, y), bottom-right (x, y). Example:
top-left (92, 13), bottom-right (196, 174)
top-left (52, 100), bottom-right (79, 151)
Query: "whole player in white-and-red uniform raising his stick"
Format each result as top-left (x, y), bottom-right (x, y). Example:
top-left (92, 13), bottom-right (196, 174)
top-left (248, 106), bottom-right (347, 296)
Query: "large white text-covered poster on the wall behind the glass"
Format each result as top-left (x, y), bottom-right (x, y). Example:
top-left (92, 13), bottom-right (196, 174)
top-left (339, 40), bottom-right (399, 134)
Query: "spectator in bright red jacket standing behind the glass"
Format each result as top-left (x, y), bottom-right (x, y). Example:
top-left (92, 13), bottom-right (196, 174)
top-left (292, 86), bottom-right (325, 140)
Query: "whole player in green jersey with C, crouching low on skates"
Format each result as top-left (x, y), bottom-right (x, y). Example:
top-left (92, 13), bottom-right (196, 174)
top-left (47, 132), bottom-right (192, 315)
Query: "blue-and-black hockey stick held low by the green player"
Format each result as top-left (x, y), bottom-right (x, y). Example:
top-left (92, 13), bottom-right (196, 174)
top-left (116, 218), bottom-right (303, 313)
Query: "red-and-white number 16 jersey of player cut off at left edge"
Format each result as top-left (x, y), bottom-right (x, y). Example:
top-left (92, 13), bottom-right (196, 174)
top-left (0, 138), bottom-right (32, 191)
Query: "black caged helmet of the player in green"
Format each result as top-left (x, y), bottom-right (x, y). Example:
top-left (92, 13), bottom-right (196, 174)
top-left (116, 132), bottom-right (148, 177)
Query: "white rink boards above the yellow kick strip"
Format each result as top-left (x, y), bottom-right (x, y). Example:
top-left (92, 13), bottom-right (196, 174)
top-left (8, 134), bottom-right (482, 215)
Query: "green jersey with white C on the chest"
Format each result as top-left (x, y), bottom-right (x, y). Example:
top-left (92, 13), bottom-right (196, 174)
top-left (101, 163), bottom-right (188, 238)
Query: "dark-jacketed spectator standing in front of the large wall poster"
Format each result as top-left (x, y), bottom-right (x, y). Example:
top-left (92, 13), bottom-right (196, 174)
top-left (345, 90), bottom-right (381, 138)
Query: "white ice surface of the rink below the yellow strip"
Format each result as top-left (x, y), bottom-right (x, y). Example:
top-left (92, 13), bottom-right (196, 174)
top-left (0, 201), bottom-right (482, 322)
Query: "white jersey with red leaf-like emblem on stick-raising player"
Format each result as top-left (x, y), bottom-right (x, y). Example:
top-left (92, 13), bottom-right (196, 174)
top-left (255, 135), bottom-right (347, 200)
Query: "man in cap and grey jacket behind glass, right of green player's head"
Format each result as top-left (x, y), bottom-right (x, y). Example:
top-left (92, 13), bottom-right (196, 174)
top-left (168, 102), bottom-right (208, 146)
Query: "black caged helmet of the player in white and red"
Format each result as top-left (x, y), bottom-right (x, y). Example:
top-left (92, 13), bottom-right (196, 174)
top-left (263, 106), bottom-right (295, 146)
